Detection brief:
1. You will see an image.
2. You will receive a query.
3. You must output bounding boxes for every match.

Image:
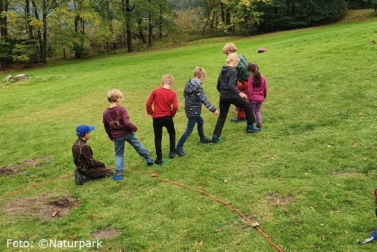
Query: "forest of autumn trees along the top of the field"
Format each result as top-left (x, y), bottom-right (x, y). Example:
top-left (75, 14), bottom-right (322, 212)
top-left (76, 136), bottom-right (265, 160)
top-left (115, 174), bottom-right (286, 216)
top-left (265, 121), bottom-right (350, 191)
top-left (0, 0), bottom-right (377, 69)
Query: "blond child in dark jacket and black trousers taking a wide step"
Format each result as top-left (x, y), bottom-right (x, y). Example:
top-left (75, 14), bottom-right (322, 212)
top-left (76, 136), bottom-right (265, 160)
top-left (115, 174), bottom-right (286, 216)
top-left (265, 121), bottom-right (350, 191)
top-left (212, 53), bottom-right (259, 143)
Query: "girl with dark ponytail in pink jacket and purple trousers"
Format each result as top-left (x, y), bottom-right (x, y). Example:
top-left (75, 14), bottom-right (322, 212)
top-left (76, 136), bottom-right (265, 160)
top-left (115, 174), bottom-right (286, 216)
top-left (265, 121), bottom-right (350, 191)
top-left (247, 63), bottom-right (267, 130)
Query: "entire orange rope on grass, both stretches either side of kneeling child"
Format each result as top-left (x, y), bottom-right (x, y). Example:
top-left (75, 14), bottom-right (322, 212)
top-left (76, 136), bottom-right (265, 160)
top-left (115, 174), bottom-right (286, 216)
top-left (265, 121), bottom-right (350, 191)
top-left (0, 168), bottom-right (283, 252)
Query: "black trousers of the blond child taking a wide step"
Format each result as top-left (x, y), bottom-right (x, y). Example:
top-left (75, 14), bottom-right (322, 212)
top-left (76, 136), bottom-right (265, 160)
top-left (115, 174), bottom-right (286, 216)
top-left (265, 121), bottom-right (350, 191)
top-left (213, 97), bottom-right (255, 137)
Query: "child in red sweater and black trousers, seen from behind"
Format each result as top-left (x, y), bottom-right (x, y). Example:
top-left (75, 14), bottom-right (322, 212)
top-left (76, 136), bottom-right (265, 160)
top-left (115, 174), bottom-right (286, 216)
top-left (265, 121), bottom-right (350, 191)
top-left (146, 74), bottom-right (178, 165)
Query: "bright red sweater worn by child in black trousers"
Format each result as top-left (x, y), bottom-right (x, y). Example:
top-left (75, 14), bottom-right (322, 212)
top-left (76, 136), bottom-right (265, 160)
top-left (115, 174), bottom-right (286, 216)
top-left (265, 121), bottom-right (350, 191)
top-left (146, 87), bottom-right (178, 118)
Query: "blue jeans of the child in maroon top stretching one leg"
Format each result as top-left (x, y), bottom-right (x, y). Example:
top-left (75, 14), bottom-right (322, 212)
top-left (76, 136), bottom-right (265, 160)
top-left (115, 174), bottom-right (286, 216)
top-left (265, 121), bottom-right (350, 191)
top-left (114, 132), bottom-right (149, 173)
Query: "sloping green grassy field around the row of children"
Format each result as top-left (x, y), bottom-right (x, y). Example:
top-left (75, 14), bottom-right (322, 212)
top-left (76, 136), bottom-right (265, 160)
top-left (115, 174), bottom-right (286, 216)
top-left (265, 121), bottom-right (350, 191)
top-left (0, 10), bottom-right (377, 252)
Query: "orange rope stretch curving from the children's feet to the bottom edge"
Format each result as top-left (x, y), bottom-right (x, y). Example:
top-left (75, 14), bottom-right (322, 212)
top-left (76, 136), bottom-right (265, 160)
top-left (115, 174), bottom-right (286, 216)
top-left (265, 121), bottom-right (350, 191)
top-left (126, 168), bottom-right (283, 252)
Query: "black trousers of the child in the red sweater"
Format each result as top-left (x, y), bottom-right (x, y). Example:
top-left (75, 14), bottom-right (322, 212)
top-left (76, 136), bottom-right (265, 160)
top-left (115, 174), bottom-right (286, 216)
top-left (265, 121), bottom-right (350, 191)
top-left (153, 116), bottom-right (175, 159)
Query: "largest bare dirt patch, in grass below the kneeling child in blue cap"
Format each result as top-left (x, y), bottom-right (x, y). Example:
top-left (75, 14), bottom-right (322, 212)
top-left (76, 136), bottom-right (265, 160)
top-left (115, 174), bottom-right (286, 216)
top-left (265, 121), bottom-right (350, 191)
top-left (5, 195), bottom-right (80, 219)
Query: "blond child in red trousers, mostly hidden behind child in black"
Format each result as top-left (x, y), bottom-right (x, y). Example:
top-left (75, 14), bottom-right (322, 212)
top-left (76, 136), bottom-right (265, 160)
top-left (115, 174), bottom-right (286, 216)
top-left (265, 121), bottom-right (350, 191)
top-left (223, 43), bottom-right (250, 123)
